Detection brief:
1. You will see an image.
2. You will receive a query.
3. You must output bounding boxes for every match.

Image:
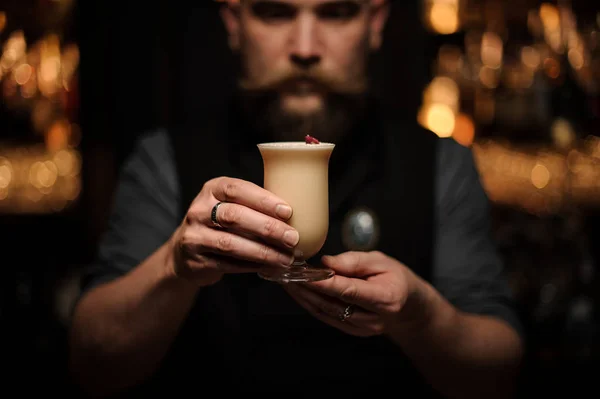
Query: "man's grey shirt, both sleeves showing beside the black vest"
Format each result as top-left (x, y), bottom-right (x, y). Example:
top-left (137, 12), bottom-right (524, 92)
top-left (82, 130), bottom-right (522, 332)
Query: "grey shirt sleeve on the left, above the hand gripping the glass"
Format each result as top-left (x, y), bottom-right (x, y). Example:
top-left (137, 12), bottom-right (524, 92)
top-left (81, 131), bottom-right (179, 295)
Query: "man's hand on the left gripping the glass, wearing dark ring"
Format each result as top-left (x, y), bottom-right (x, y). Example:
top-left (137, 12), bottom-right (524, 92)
top-left (167, 177), bottom-right (299, 286)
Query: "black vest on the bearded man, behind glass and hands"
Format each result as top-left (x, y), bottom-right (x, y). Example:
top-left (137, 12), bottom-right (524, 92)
top-left (145, 97), bottom-right (436, 397)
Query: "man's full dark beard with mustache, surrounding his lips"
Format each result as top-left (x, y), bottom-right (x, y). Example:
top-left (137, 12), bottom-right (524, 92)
top-left (240, 73), bottom-right (367, 143)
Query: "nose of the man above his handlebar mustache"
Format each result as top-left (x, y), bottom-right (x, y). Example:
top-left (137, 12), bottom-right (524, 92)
top-left (290, 15), bottom-right (321, 69)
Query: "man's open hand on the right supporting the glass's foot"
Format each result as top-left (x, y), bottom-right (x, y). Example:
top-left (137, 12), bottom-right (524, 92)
top-left (284, 252), bottom-right (427, 336)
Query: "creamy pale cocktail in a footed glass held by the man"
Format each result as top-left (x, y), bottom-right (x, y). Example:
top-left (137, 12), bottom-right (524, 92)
top-left (258, 141), bottom-right (335, 283)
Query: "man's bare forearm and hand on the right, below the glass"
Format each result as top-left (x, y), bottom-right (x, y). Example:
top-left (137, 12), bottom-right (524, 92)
top-left (284, 252), bottom-right (522, 398)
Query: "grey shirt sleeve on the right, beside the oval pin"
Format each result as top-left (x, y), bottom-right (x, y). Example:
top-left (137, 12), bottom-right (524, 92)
top-left (433, 139), bottom-right (523, 334)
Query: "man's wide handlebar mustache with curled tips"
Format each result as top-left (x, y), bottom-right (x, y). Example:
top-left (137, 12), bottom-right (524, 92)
top-left (239, 71), bottom-right (367, 94)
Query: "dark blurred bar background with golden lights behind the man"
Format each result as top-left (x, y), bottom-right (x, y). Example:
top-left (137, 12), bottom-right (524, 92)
top-left (0, 0), bottom-right (600, 397)
